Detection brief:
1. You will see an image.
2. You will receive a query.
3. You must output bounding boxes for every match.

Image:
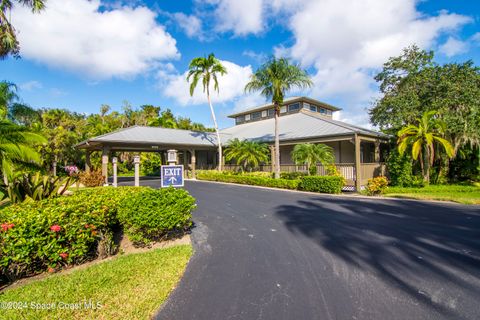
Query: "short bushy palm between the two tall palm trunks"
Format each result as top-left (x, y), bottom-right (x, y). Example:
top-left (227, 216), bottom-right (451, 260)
top-left (225, 138), bottom-right (269, 170)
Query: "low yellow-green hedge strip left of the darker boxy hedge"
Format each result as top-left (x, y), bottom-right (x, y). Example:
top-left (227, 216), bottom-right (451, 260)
top-left (197, 171), bottom-right (300, 189)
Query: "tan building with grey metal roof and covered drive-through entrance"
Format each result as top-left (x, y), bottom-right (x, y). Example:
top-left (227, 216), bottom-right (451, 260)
top-left (77, 97), bottom-right (388, 189)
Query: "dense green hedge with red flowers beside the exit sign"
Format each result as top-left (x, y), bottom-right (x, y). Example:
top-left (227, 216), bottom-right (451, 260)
top-left (0, 187), bottom-right (194, 282)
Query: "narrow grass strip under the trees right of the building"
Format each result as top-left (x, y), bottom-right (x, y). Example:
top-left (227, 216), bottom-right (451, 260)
top-left (385, 185), bottom-right (480, 204)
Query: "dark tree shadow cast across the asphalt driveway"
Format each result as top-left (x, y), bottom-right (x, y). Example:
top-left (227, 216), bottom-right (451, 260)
top-left (276, 197), bottom-right (480, 319)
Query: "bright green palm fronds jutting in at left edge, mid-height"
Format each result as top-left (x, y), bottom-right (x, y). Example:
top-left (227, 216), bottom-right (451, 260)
top-left (0, 120), bottom-right (46, 184)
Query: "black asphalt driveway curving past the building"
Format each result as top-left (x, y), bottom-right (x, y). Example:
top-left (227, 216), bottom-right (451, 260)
top-left (124, 181), bottom-right (480, 320)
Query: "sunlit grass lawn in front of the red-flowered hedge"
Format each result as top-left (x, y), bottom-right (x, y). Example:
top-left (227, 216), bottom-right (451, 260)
top-left (0, 245), bottom-right (192, 319)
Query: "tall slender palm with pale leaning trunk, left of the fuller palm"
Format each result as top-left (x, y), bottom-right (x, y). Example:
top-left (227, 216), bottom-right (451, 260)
top-left (187, 53), bottom-right (227, 171)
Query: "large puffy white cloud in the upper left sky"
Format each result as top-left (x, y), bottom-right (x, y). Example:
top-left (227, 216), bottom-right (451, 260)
top-left (12, 0), bottom-right (179, 79)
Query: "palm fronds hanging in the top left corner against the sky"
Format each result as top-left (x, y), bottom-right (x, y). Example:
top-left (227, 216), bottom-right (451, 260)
top-left (0, 0), bottom-right (45, 59)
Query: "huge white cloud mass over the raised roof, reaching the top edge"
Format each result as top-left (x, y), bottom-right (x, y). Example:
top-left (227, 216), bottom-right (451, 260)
top-left (197, 0), bottom-right (470, 124)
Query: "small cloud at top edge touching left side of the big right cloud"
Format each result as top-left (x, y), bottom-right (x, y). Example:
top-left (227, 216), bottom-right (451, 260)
top-left (205, 0), bottom-right (265, 36)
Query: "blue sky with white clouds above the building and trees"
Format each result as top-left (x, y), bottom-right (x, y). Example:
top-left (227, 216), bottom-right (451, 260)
top-left (0, 0), bottom-right (480, 127)
